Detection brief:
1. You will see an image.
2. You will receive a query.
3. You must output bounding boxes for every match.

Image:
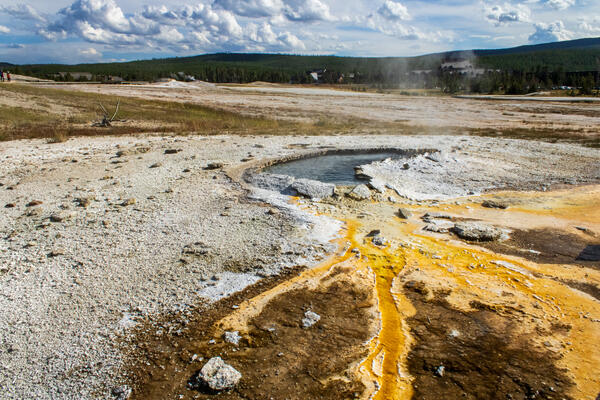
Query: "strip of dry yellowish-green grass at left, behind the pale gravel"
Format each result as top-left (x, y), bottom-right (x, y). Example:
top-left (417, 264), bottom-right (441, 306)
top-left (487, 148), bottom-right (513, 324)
top-left (0, 84), bottom-right (384, 142)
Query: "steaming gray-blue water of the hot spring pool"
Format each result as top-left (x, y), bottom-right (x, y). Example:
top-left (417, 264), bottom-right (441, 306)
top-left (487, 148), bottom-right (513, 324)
top-left (264, 152), bottom-right (402, 185)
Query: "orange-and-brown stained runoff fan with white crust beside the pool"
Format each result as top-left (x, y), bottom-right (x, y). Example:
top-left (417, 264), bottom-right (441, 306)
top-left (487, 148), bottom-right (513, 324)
top-left (123, 146), bottom-right (600, 400)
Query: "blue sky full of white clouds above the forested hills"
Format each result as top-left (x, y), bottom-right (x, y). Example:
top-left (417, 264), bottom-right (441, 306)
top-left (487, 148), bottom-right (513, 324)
top-left (0, 0), bottom-right (600, 64)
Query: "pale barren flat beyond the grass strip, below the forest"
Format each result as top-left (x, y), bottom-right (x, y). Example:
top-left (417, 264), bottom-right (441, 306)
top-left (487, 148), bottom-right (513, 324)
top-left (45, 83), bottom-right (600, 138)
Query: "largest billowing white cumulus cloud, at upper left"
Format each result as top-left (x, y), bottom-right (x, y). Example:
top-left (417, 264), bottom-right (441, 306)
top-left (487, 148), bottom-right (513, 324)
top-left (20, 0), bottom-right (310, 53)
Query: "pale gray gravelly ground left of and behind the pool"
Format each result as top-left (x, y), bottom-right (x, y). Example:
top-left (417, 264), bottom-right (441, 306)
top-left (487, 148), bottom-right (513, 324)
top-left (0, 136), bottom-right (600, 399)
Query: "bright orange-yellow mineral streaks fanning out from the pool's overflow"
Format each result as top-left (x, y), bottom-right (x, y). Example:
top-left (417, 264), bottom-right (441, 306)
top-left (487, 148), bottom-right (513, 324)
top-left (221, 186), bottom-right (600, 400)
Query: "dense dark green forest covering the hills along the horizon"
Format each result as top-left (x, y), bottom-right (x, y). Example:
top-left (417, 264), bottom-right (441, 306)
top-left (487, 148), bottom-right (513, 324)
top-left (5, 38), bottom-right (600, 95)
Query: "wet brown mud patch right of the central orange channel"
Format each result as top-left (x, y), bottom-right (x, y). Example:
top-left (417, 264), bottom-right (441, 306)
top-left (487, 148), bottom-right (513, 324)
top-left (404, 282), bottom-right (573, 400)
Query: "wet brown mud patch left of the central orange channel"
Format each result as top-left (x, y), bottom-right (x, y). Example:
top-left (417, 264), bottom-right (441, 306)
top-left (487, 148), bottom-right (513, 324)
top-left (124, 266), bottom-right (375, 399)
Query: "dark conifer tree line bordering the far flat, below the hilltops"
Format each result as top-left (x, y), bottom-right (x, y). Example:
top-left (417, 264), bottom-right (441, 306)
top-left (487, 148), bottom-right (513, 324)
top-left (13, 55), bottom-right (600, 95)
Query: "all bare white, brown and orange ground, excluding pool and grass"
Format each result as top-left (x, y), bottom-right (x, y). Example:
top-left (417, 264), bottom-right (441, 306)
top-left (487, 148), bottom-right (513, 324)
top-left (0, 84), bottom-right (600, 400)
